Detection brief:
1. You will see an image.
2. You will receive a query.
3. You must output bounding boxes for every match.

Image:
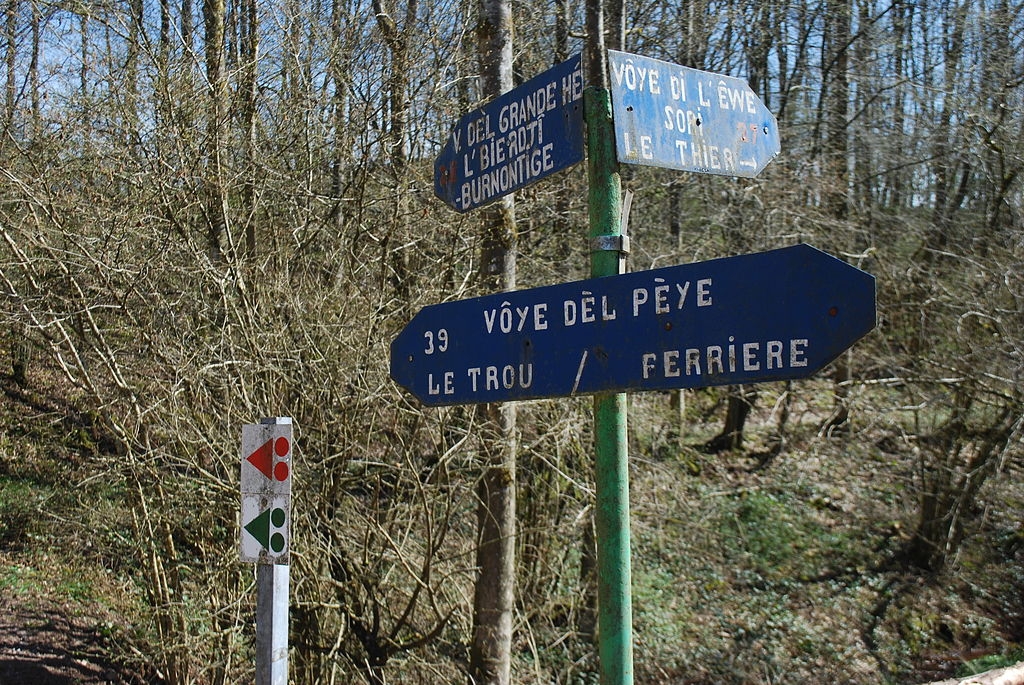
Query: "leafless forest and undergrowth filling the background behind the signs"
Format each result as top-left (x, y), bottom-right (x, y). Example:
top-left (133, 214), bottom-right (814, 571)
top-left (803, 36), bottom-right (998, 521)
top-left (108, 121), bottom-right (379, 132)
top-left (0, 0), bottom-right (1024, 683)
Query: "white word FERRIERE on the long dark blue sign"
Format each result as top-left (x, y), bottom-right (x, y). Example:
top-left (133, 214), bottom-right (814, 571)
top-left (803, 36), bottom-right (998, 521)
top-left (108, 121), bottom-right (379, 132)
top-left (640, 336), bottom-right (809, 380)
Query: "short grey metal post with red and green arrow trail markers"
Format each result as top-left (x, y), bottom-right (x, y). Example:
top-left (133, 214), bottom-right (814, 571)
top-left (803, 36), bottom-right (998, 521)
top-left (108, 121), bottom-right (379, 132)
top-left (240, 417), bottom-right (293, 685)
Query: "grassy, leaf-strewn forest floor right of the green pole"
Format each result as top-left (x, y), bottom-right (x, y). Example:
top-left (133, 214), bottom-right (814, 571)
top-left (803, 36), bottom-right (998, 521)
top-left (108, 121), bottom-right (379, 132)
top-left (614, 388), bottom-right (1021, 685)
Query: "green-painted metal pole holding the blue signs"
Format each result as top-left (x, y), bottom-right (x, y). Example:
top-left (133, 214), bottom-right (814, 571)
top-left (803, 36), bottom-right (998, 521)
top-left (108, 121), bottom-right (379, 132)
top-left (584, 86), bottom-right (633, 685)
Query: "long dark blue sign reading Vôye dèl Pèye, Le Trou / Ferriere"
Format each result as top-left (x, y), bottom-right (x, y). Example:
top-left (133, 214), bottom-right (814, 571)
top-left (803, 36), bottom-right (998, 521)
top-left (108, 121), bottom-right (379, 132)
top-left (391, 245), bottom-right (874, 405)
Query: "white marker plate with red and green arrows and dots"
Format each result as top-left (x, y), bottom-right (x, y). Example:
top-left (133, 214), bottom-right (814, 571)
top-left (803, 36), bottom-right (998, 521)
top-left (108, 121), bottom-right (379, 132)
top-left (240, 418), bottom-right (294, 564)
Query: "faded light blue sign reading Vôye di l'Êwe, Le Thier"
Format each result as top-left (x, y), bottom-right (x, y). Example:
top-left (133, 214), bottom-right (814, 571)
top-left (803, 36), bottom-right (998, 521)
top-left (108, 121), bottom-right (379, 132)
top-left (608, 50), bottom-right (779, 177)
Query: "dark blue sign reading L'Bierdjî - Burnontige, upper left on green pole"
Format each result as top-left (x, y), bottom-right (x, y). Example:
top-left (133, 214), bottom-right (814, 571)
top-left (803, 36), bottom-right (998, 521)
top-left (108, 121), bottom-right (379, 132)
top-left (434, 54), bottom-right (584, 212)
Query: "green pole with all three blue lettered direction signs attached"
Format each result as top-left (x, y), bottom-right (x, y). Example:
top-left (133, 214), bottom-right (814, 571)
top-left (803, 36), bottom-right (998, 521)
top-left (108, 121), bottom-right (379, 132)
top-left (407, 42), bottom-right (876, 685)
